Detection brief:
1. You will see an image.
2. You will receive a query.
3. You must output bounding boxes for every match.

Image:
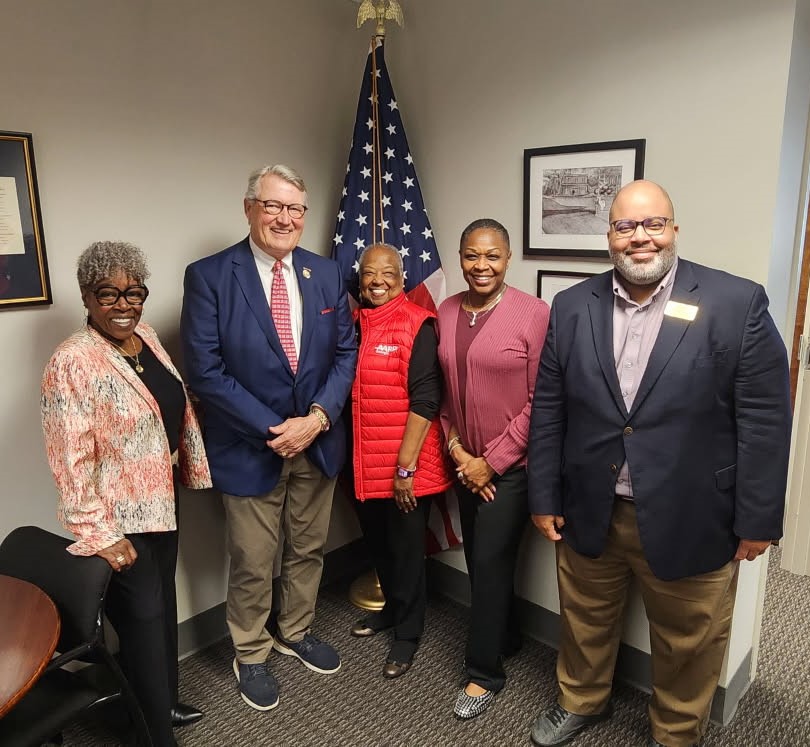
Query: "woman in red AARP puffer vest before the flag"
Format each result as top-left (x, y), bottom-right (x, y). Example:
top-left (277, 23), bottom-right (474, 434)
top-left (351, 244), bottom-right (452, 679)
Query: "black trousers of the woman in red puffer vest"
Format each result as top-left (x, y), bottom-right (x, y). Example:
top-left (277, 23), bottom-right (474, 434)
top-left (355, 496), bottom-right (433, 642)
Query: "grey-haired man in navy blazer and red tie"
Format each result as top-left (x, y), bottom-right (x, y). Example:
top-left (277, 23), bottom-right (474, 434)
top-left (182, 165), bottom-right (357, 711)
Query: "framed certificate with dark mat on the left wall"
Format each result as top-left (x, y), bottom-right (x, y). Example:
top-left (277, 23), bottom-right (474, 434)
top-left (0, 131), bottom-right (53, 309)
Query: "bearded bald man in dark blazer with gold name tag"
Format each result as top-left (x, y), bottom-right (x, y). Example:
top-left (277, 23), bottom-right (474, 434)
top-left (529, 181), bottom-right (791, 747)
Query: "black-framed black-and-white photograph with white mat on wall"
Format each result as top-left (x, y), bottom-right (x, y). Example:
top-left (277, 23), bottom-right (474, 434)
top-left (523, 140), bottom-right (646, 259)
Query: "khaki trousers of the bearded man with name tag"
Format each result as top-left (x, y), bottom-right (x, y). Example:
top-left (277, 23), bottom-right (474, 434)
top-left (557, 500), bottom-right (739, 747)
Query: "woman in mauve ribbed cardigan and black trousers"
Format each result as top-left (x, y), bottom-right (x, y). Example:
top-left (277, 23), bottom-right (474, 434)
top-left (438, 218), bottom-right (549, 719)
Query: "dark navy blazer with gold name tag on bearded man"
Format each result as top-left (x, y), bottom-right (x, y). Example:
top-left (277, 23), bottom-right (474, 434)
top-left (529, 259), bottom-right (791, 580)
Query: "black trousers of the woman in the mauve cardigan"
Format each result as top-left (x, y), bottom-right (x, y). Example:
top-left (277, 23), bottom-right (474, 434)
top-left (456, 467), bottom-right (529, 692)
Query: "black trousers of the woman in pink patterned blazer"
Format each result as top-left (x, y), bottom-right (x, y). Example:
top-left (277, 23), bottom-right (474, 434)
top-left (106, 531), bottom-right (178, 747)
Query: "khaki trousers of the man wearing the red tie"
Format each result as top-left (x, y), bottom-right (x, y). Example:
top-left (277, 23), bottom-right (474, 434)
top-left (222, 454), bottom-right (335, 664)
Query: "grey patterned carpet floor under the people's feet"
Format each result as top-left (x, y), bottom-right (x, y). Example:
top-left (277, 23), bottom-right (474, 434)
top-left (64, 550), bottom-right (810, 747)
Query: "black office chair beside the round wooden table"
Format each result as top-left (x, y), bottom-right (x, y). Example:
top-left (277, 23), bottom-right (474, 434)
top-left (0, 527), bottom-right (152, 747)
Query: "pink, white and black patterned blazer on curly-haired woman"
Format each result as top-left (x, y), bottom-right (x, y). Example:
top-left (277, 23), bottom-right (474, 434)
top-left (41, 322), bottom-right (211, 555)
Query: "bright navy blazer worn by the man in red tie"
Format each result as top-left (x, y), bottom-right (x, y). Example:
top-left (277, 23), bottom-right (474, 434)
top-left (181, 239), bottom-right (357, 495)
